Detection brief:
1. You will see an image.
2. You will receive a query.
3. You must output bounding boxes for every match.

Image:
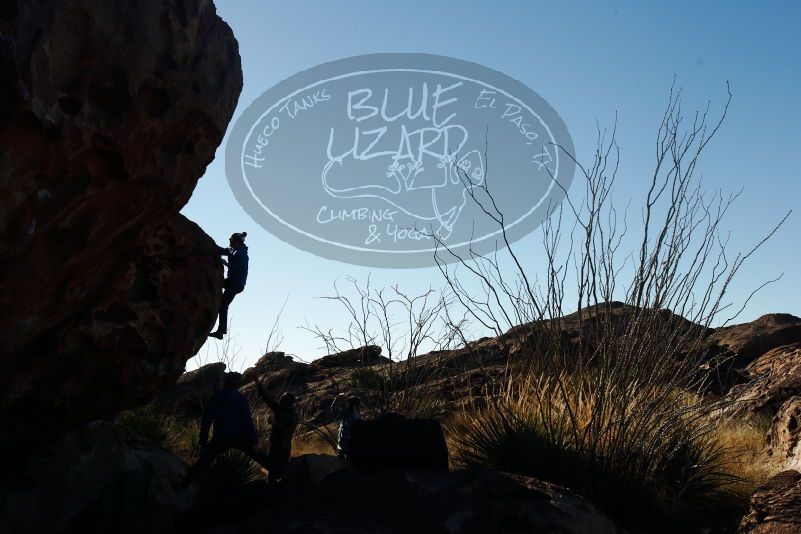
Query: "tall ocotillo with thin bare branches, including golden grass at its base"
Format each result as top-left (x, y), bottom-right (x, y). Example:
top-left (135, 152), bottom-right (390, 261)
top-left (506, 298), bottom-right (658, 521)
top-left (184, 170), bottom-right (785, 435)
top-left (437, 84), bottom-right (787, 532)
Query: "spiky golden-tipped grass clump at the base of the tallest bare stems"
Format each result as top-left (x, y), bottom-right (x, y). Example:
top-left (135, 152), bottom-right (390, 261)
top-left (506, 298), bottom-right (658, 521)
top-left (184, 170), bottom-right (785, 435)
top-left (451, 377), bottom-right (738, 532)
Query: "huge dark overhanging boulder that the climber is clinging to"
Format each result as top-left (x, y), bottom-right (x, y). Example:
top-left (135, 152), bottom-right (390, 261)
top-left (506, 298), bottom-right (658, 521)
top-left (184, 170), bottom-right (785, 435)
top-left (0, 0), bottom-right (242, 452)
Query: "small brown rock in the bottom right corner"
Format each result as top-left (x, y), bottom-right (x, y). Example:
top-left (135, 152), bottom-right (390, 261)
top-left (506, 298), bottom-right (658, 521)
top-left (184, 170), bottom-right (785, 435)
top-left (738, 470), bottom-right (801, 534)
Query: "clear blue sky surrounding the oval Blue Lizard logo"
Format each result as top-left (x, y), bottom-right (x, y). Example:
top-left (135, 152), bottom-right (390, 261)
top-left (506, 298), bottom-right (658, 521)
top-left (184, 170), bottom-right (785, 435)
top-left (183, 0), bottom-right (801, 368)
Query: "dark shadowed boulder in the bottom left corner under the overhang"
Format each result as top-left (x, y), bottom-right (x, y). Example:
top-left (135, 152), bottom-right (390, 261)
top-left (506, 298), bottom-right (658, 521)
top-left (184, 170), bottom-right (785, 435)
top-left (0, 422), bottom-right (192, 534)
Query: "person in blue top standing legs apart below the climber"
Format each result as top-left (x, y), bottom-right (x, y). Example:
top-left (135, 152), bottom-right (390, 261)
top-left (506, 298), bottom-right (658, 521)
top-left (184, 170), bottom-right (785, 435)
top-left (181, 373), bottom-right (269, 488)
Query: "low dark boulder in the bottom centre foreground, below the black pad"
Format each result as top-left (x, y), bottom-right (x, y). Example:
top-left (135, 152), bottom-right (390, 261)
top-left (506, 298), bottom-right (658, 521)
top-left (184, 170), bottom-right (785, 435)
top-left (230, 469), bottom-right (618, 534)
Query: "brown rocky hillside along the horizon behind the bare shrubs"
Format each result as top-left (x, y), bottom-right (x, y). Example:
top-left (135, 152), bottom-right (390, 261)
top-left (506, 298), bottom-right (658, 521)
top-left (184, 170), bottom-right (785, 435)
top-left (172, 304), bottom-right (801, 446)
